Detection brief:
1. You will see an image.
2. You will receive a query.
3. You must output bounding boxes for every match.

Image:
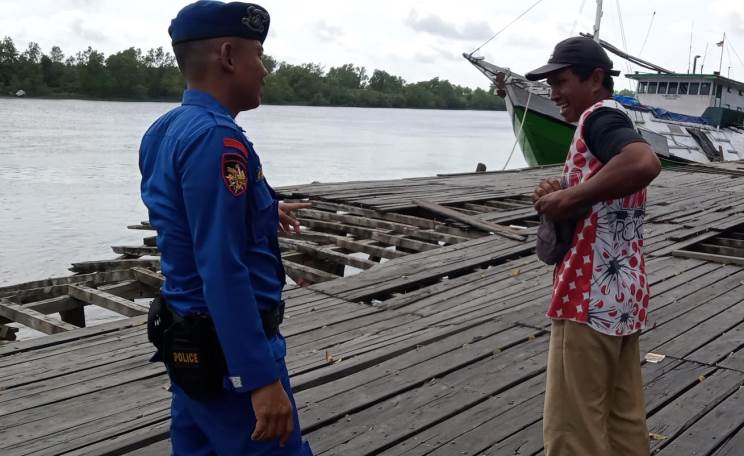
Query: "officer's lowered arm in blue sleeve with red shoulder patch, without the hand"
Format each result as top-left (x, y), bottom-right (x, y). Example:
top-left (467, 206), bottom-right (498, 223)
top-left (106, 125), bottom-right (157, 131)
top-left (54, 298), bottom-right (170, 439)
top-left (178, 128), bottom-right (279, 391)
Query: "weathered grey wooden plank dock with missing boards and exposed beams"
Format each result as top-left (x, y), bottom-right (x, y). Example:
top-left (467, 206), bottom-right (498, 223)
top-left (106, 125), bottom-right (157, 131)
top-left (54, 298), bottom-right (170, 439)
top-left (0, 164), bottom-right (744, 456)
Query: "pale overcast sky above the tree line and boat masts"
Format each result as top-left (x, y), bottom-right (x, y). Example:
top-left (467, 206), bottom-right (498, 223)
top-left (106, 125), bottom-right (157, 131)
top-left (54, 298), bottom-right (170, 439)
top-left (0, 0), bottom-right (744, 88)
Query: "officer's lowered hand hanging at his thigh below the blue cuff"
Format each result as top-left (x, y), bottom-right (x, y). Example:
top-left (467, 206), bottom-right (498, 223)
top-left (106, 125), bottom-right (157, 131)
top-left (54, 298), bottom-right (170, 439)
top-left (251, 380), bottom-right (294, 446)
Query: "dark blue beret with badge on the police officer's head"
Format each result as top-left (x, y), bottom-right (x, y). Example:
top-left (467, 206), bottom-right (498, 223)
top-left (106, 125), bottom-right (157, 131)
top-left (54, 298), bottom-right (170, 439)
top-left (168, 0), bottom-right (270, 45)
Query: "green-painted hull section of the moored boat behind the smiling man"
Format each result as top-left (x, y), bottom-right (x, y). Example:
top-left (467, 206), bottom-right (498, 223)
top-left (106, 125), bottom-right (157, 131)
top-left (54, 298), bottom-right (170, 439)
top-left (512, 106), bottom-right (685, 168)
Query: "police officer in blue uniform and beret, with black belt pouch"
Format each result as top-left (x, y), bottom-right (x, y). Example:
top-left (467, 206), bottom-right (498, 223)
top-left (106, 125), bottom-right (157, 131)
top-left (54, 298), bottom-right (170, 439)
top-left (140, 1), bottom-right (312, 456)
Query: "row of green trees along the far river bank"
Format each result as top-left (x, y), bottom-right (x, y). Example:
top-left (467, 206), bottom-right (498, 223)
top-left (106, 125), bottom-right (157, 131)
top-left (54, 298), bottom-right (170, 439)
top-left (0, 37), bottom-right (505, 110)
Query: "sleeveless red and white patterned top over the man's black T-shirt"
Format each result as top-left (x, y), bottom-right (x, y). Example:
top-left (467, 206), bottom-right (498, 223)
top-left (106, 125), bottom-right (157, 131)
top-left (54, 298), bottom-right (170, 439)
top-left (547, 100), bottom-right (649, 336)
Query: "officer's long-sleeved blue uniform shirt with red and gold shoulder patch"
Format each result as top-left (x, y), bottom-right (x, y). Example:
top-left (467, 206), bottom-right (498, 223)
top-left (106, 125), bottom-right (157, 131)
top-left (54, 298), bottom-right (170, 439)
top-left (139, 90), bottom-right (285, 391)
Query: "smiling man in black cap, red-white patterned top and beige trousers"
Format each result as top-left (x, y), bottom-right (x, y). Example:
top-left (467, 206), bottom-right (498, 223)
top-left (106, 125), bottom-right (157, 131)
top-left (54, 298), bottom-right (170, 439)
top-left (526, 38), bottom-right (661, 456)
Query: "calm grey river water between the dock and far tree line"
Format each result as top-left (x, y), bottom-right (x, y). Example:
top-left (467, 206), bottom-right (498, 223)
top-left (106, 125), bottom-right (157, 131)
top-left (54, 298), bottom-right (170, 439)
top-left (0, 98), bottom-right (525, 338)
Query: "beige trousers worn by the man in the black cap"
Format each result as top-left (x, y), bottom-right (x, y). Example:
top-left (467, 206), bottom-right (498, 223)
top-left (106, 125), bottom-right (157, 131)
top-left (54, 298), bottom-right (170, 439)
top-left (543, 320), bottom-right (649, 456)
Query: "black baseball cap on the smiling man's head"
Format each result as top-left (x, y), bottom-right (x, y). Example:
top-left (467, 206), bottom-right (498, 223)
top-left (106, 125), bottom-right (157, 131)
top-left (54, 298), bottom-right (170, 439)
top-left (524, 36), bottom-right (620, 81)
